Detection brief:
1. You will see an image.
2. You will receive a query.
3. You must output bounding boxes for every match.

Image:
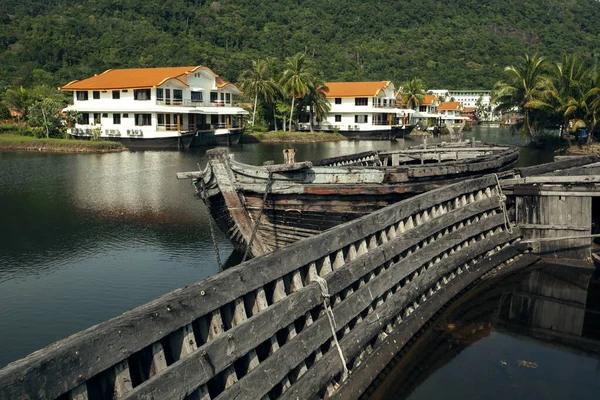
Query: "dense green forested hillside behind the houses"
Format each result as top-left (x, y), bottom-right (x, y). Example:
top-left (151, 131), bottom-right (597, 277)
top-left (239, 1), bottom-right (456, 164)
top-left (0, 0), bottom-right (600, 90)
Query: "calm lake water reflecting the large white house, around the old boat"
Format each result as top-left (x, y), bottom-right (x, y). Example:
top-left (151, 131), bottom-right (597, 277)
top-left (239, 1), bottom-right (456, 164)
top-left (0, 128), bottom-right (598, 398)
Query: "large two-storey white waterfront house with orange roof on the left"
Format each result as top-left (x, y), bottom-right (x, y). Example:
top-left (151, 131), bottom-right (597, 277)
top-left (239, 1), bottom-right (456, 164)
top-left (59, 66), bottom-right (248, 148)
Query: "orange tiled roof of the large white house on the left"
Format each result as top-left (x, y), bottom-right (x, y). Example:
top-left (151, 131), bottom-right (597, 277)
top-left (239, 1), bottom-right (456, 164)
top-left (60, 66), bottom-right (239, 90)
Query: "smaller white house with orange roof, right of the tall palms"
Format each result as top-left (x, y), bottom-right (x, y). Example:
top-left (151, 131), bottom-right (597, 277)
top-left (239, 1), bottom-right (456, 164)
top-left (300, 81), bottom-right (410, 139)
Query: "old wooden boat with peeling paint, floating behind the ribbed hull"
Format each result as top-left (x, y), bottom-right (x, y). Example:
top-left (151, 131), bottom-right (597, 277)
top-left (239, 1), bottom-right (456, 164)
top-left (178, 142), bottom-right (519, 256)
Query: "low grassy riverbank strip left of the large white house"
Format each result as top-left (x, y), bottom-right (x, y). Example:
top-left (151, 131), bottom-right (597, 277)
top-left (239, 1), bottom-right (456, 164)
top-left (0, 133), bottom-right (126, 153)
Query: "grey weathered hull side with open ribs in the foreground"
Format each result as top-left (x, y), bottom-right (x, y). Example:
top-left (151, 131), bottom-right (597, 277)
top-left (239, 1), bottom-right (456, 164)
top-left (0, 173), bottom-right (538, 400)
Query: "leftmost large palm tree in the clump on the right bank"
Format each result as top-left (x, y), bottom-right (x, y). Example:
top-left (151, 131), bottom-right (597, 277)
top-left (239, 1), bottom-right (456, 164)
top-left (493, 55), bottom-right (554, 142)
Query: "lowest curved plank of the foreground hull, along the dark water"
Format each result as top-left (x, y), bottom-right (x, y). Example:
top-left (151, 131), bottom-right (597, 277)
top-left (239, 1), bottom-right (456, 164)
top-left (332, 253), bottom-right (539, 400)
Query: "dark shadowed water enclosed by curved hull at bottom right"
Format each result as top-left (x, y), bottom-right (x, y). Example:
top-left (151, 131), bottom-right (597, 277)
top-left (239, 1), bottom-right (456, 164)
top-left (365, 265), bottom-right (600, 399)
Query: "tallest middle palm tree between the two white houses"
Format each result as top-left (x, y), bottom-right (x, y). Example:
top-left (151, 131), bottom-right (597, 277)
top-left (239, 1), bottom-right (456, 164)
top-left (280, 53), bottom-right (315, 132)
